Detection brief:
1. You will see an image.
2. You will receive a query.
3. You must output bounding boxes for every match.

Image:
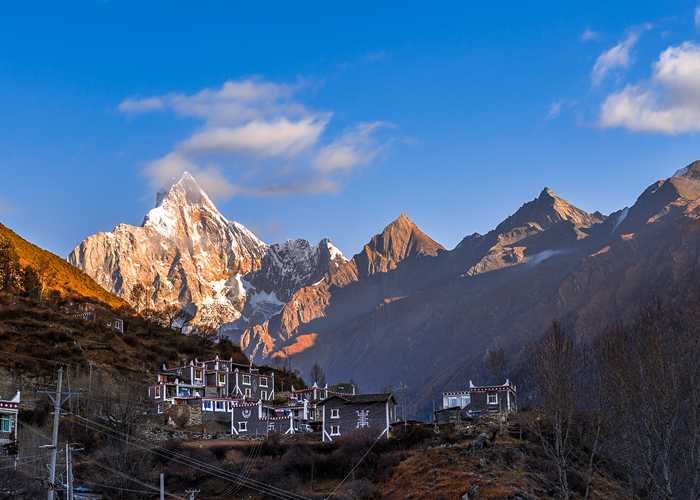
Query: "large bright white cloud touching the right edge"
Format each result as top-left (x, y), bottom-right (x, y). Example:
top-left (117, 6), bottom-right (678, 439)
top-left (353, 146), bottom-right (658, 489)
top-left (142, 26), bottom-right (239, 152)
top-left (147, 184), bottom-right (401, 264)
top-left (600, 42), bottom-right (700, 134)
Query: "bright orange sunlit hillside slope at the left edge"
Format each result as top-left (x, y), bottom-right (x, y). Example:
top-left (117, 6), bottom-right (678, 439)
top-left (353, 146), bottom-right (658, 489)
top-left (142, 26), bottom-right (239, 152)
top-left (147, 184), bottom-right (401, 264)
top-left (0, 224), bottom-right (128, 308)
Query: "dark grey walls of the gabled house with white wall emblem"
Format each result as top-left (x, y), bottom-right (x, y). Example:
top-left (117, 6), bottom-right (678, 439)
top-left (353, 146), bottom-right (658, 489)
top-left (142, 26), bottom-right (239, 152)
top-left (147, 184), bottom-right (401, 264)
top-left (320, 399), bottom-right (396, 441)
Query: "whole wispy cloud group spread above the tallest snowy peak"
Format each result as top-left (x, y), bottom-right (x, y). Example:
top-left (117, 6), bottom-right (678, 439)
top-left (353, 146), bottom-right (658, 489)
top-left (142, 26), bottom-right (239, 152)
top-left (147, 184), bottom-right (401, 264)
top-left (117, 78), bottom-right (394, 197)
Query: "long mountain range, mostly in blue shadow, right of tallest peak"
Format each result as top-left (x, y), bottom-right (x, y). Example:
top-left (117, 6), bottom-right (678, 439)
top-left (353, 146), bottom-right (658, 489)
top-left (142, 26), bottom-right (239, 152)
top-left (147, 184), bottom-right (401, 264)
top-left (75, 162), bottom-right (700, 410)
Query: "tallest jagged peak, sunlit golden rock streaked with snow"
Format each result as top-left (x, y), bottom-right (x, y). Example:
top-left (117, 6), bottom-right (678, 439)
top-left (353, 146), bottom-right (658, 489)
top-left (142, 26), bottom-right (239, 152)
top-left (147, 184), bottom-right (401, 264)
top-left (68, 173), bottom-right (268, 326)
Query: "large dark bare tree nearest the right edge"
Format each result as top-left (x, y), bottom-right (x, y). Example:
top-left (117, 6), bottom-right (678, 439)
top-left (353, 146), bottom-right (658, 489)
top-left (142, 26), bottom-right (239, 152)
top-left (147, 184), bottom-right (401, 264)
top-left (601, 306), bottom-right (700, 499)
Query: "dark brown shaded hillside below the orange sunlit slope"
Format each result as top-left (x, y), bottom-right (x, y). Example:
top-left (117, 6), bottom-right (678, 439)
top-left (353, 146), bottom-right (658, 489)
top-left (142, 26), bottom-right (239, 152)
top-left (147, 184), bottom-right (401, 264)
top-left (0, 293), bottom-right (247, 383)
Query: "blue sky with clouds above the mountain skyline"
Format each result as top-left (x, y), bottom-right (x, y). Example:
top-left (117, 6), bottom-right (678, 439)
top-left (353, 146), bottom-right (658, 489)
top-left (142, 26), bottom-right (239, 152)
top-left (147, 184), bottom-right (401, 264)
top-left (0, 1), bottom-right (700, 255)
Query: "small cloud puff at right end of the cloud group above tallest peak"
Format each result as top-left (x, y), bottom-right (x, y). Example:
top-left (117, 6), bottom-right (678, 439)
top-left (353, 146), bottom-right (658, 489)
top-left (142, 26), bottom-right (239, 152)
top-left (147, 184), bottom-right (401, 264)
top-left (314, 122), bottom-right (392, 173)
